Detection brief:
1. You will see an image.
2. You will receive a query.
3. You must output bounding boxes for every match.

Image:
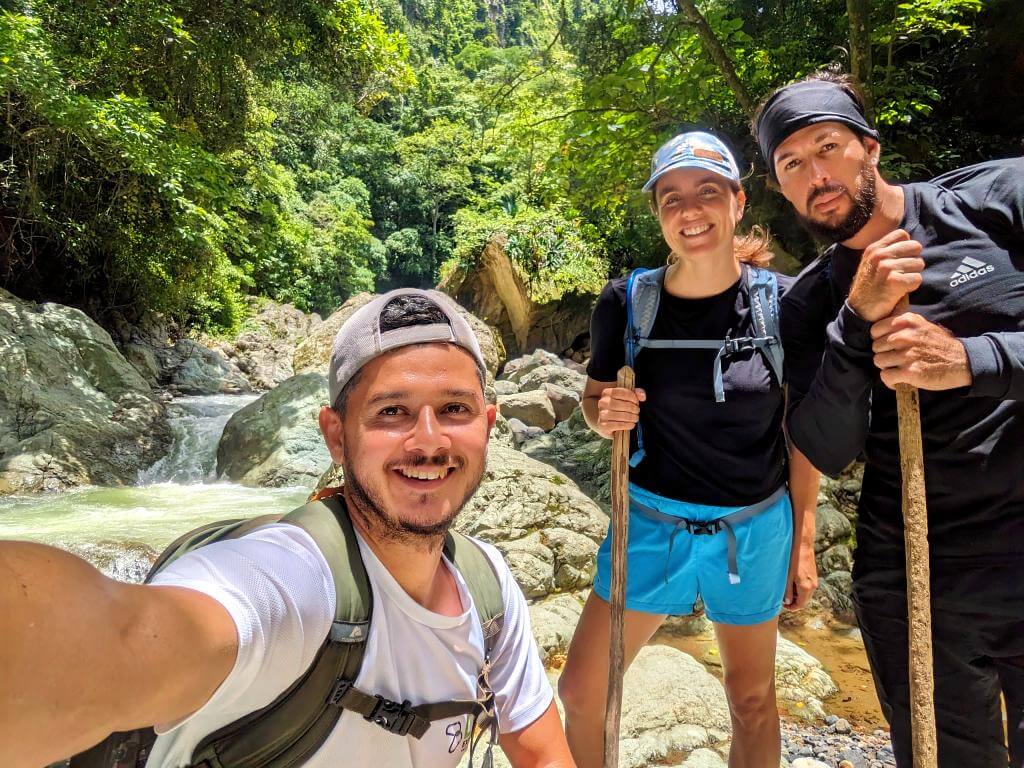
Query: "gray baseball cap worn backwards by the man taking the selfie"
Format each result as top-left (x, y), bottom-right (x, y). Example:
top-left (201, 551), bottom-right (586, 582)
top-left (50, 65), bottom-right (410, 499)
top-left (328, 288), bottom-right (486, 406)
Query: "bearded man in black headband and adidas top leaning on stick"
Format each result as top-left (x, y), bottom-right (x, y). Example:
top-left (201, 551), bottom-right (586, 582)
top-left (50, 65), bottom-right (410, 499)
top-left (753, 72), bottom-right (1024, 768)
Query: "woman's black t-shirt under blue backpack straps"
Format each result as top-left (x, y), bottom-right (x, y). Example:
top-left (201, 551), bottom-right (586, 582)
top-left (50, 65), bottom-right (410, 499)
top-left (587, 268), bottom-right (793, 506)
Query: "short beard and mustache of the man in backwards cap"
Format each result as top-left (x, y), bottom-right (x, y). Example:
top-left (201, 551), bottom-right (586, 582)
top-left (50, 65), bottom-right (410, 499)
top-left (341, 443), bottom-right (484, 549)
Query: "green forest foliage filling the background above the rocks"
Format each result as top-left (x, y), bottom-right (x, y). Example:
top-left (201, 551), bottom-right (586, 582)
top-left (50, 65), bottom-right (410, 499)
top-left (0, 0), bottom-right (1024, 329)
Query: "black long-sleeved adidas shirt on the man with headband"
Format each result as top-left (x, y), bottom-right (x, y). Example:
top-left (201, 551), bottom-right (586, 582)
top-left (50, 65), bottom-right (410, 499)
top-left (781, 159), bottom-right (1024, 563)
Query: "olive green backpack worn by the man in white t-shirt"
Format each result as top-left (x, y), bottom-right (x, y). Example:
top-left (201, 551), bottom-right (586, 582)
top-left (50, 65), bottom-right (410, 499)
top-left (71, 496), bottom-right (505, 768)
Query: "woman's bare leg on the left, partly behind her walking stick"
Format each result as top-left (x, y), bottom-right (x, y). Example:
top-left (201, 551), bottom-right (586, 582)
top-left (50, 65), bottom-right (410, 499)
top-left (558, 592), bottom-right (665, 768)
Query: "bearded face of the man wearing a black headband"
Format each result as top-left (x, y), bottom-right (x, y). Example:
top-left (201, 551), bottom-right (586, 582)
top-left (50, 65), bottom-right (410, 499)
top-left (773, 122), bottom-right (879, 243)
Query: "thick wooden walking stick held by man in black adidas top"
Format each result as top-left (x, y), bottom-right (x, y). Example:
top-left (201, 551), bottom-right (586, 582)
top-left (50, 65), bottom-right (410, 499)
top-left (897, 296), bottom-right (938, 768)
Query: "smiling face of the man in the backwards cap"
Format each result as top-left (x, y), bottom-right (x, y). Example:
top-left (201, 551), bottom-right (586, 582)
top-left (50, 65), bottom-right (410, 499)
top-left (321, 343), bottom-right (497, 543)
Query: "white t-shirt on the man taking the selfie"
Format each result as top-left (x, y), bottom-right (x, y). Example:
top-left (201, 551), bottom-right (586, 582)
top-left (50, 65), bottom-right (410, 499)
top-left (147, 524), bottom-right (553, 768)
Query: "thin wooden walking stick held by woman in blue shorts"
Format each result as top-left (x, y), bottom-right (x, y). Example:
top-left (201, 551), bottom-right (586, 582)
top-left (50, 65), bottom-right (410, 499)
top-left (604, 366), bottom-right (634, 768)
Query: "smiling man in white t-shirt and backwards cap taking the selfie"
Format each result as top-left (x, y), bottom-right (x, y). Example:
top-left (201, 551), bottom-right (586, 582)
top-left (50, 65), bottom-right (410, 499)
top-left (0, 289), bottom-right (572, 768)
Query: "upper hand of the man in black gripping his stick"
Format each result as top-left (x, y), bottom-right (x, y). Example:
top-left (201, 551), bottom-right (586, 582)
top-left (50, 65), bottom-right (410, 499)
top-left (847, 229), bottom-right (925, 323)
